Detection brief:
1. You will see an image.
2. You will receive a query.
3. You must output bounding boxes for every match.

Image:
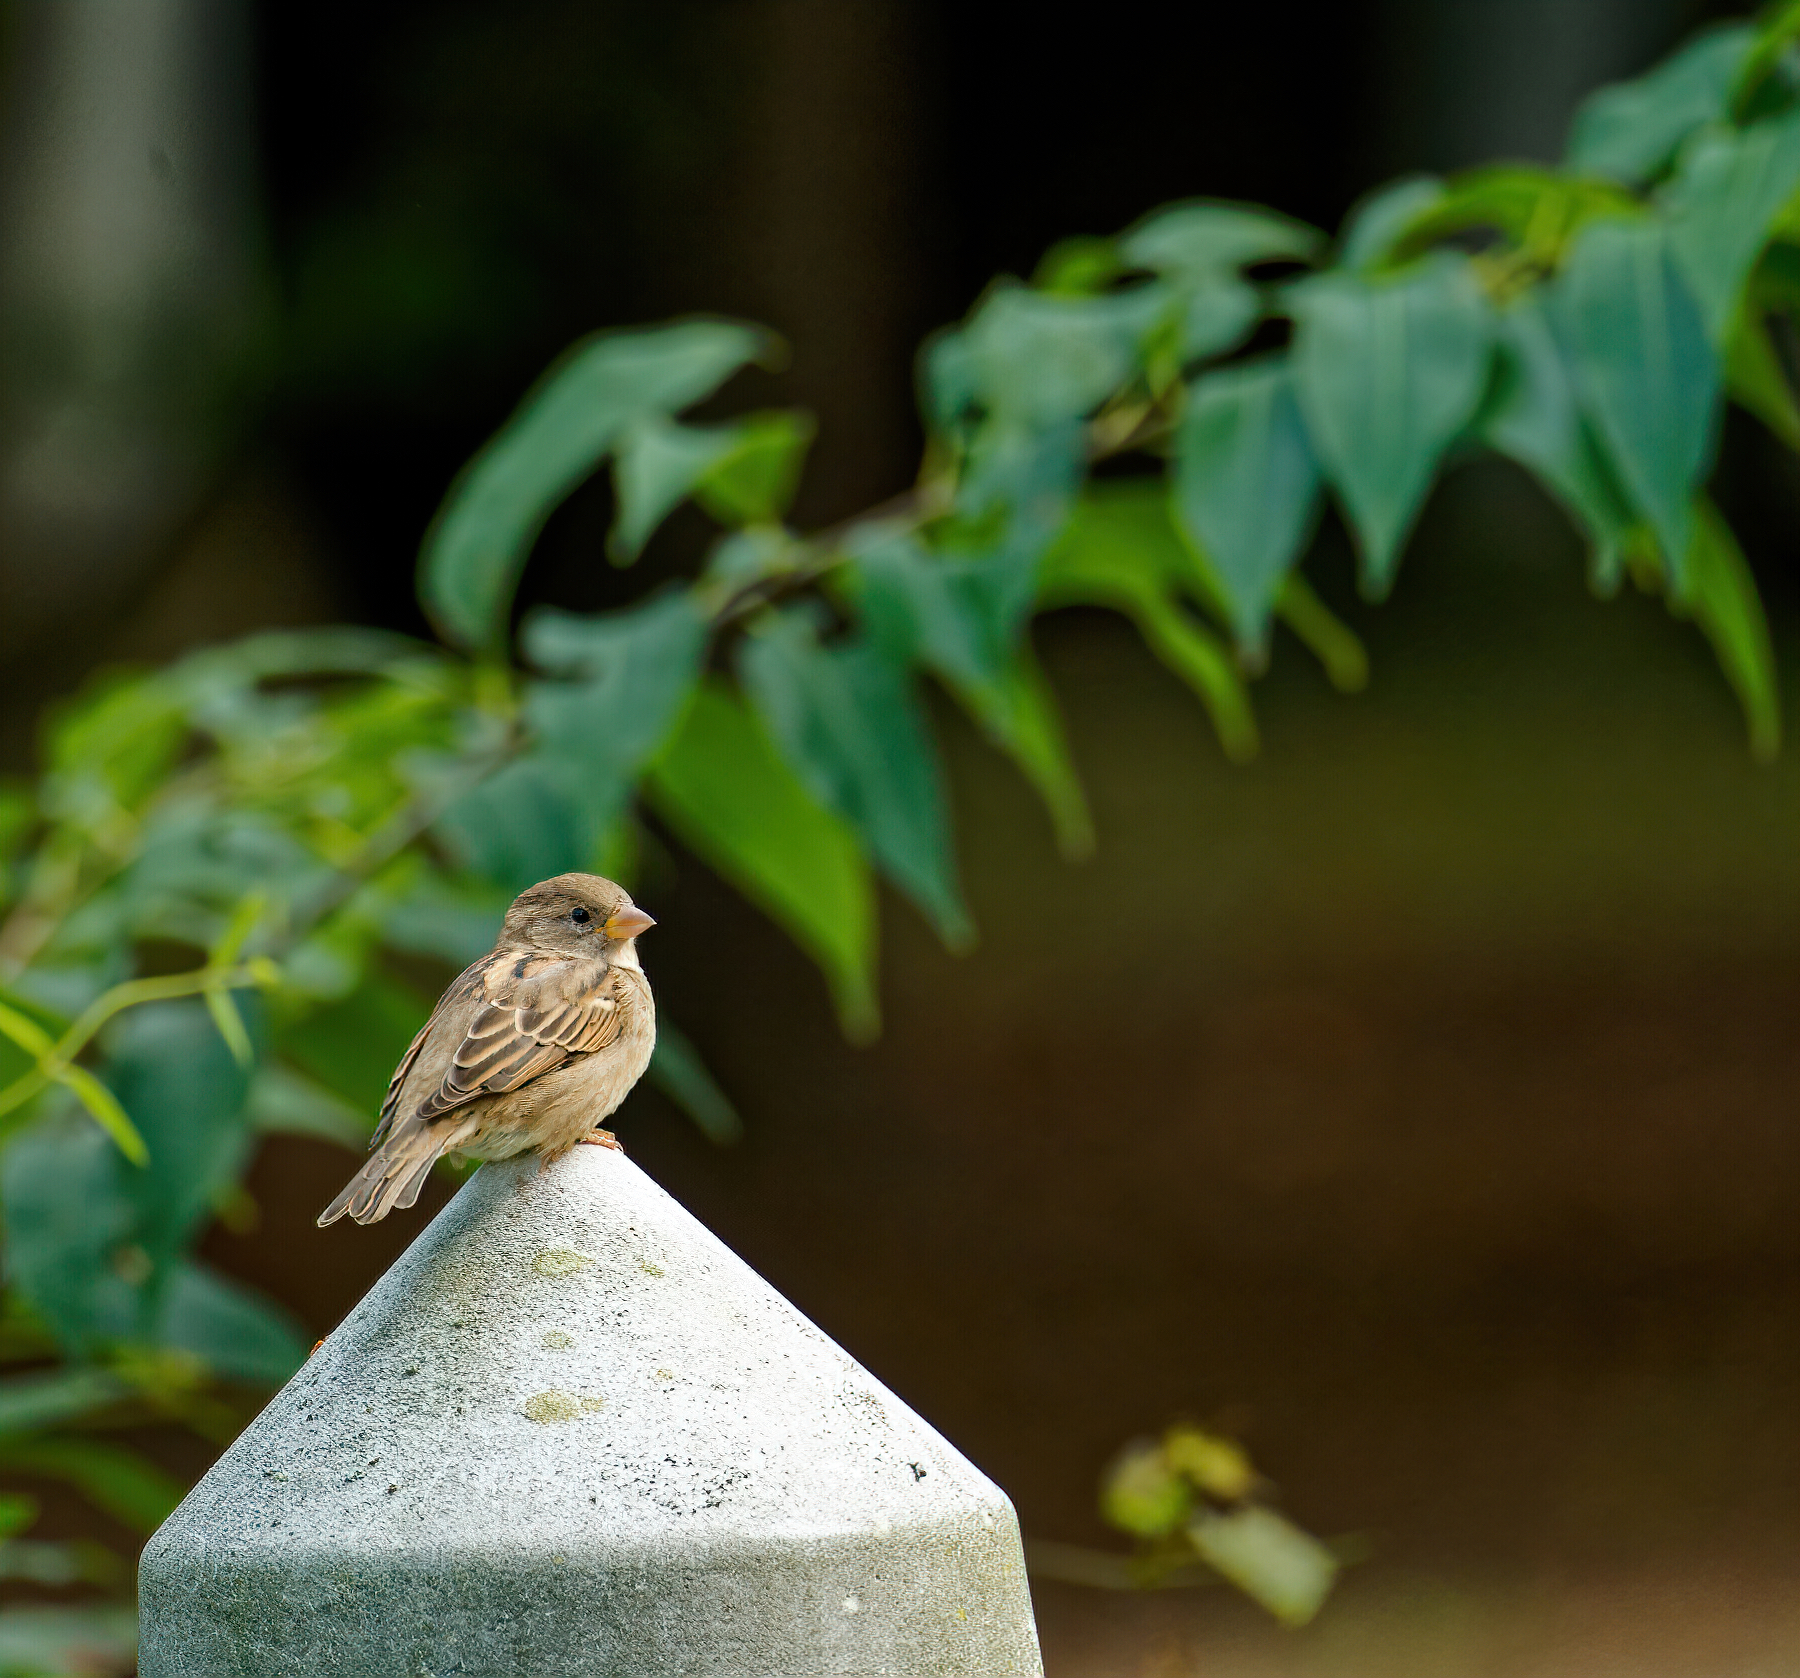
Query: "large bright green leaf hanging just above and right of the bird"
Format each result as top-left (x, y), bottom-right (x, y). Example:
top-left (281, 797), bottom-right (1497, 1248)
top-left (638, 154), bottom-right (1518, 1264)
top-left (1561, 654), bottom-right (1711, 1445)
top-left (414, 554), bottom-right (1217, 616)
top-left (644, 681), bottom-right (877, 1039)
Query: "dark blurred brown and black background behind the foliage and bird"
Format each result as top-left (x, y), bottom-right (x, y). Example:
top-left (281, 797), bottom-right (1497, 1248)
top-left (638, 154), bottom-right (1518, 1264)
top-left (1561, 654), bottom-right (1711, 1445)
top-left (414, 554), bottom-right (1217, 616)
top-left (0, 0), bottom-right (1800, 1678)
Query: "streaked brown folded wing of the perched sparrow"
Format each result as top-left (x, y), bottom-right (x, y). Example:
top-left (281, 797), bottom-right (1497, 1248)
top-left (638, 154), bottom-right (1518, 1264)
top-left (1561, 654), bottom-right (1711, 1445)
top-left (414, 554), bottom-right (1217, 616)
top-left (418, 956), bottom-right (625, 1123)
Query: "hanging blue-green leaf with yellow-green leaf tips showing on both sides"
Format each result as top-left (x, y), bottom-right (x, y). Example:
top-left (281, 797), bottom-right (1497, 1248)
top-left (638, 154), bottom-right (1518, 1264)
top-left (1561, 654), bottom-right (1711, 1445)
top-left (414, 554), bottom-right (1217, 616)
top-left (1174, 356), bottom-right (1319, 648)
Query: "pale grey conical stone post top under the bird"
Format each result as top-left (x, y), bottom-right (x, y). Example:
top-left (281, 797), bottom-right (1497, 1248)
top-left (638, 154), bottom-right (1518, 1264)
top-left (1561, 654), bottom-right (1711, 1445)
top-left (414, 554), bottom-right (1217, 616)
top-left (140, 1147), bottom-right (1042, 1678)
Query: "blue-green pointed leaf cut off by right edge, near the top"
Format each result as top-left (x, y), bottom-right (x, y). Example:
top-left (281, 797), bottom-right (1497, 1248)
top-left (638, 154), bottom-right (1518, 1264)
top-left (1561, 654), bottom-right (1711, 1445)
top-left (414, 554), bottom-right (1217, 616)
top-left (1663, 108), bottom-right (1800, 344)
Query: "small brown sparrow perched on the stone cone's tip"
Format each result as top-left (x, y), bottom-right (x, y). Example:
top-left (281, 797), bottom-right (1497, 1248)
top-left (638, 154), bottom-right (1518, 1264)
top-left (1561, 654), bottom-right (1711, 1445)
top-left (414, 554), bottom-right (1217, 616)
top-left (319, 873), bottom-right (657, 1226)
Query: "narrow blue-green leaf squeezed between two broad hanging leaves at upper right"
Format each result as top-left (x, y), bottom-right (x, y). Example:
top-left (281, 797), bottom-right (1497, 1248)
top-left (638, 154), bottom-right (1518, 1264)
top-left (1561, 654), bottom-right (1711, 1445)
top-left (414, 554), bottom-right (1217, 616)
top-left (1481, 293), bottom-right (1634, 576)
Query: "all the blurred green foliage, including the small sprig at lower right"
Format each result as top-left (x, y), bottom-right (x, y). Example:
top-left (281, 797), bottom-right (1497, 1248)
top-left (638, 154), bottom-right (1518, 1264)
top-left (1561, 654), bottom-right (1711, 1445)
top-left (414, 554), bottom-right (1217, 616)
top-left (0, 7), bottom-right (1800, 1660)
